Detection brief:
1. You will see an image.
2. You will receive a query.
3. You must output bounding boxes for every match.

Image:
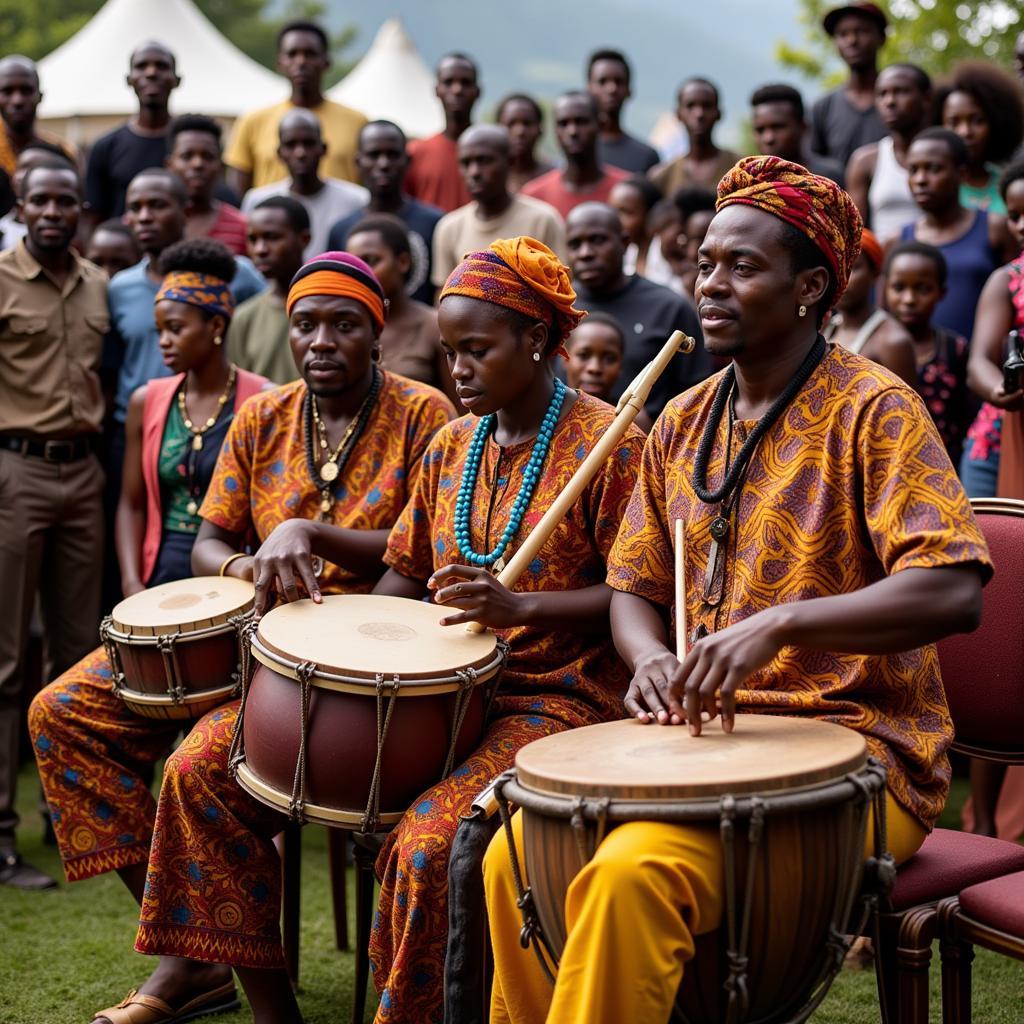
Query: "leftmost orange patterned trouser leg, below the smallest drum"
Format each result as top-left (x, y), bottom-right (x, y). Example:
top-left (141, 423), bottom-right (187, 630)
top-left (29, 647), bottom-right (188, 882)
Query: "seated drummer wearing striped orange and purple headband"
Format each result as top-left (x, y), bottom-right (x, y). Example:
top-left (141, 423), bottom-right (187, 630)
top-left (81, 252), bottom-right (454, 1024)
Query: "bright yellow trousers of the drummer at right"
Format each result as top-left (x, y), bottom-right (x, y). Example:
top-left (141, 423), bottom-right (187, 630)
top-left (483, 794), bottom-right (926, 1024)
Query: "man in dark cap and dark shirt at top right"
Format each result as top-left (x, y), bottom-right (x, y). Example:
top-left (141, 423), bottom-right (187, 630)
top-left (811, 3), bottom-right (888, 167)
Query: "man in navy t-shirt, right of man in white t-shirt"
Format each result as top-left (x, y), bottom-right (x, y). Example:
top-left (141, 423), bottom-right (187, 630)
top-left (327, 121), bottom-right (444, 305)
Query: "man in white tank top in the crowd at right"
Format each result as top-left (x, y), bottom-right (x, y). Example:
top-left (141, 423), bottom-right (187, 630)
top-left (846, 63), bottom-right (932, 245)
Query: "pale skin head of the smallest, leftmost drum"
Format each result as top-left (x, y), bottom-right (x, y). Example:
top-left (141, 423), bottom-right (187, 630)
top-left (111, 577), bottom-right (255, 636)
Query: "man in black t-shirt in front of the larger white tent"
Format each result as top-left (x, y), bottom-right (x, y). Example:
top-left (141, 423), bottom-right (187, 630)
top-left (85, 42), bottom-right (181, 230)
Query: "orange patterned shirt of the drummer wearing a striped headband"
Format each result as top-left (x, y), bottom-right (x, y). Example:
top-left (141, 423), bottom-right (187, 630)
top-left (199, 372), bottom-right (455, 594)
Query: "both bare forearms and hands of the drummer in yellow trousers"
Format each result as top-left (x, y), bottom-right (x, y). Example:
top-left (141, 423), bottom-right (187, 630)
top-left (611, 565), bottom-right (981, 736)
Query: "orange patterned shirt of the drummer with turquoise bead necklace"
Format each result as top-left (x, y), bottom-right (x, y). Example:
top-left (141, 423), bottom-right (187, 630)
top-left (384, 394), bottom-right (643, 721)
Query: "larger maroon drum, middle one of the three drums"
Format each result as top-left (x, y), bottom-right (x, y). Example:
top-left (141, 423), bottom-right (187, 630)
top-left (230, 594), bottom-right (506, 831)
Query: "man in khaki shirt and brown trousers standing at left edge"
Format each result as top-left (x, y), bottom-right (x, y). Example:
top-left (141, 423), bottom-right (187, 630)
top-left (0, 151), bottom-right (110, 889)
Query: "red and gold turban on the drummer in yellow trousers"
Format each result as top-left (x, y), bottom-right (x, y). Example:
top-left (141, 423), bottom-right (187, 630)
top-left (716, 157), bottom-right (863, 295)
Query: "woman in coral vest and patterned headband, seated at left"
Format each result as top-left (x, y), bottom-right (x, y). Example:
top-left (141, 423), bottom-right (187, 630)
top-left (116, 239), bottom-right (266, 597)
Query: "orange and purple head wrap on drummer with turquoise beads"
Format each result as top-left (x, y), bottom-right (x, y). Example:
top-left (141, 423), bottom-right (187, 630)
top-left (441, 236), bottom-right (586, 351)
